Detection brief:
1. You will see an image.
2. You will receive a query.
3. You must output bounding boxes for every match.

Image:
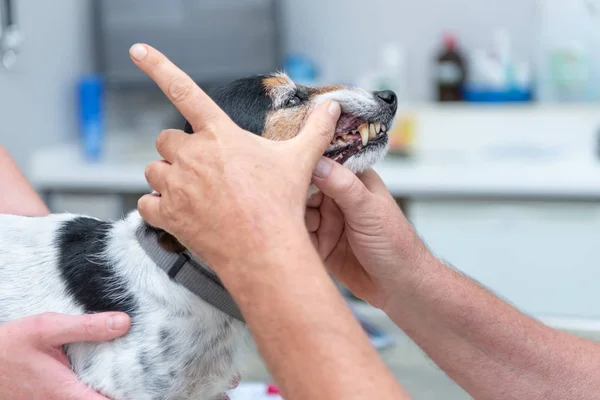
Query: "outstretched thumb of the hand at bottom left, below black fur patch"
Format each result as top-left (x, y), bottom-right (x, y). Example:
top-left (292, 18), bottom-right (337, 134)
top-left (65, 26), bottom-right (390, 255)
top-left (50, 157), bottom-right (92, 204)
top-left (31, 313), bottom-right (131, 347)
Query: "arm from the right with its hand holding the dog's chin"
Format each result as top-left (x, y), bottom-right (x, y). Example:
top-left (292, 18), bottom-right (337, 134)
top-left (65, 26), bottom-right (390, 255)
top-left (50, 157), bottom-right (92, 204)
top-left (307, 164), bottom-right (600, 400)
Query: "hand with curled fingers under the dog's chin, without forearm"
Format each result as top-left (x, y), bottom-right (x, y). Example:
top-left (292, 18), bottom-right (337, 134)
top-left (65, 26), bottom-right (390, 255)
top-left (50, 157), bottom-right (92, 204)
top-left (306, 158), bottom-right (433, 308)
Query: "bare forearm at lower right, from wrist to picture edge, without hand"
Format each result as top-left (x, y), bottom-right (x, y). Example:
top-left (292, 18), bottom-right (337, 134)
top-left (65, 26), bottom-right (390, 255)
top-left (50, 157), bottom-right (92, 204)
top-left (385, 257), bottom-right (600, 400)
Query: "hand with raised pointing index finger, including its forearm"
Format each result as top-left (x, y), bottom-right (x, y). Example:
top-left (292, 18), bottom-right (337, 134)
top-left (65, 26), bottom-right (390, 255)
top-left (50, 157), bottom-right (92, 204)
top-left (131, 45), bottom-right (407, 400)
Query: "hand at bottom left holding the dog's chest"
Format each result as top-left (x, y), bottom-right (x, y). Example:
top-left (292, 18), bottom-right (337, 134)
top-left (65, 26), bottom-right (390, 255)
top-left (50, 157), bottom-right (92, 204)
top-left (0, 313), bottom-right (130, 400)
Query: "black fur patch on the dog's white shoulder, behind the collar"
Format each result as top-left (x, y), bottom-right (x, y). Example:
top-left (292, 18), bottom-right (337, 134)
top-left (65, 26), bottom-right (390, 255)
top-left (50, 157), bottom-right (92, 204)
top-left (56, 217), bottom-right (137, 316)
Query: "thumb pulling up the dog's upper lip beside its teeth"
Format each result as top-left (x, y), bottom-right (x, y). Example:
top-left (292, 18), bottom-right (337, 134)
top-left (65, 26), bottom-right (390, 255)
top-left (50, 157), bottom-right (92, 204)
top-left (292, 101), bottom-right (342, 171)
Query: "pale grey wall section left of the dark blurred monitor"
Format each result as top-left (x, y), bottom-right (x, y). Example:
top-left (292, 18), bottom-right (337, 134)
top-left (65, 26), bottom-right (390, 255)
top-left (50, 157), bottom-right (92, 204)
top-left (0, 0), bottom-right (92, 168)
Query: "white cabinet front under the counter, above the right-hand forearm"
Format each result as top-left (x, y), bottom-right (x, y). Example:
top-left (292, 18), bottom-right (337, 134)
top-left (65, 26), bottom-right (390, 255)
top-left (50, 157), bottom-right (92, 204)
top-left (410, 201), bottom-right (600, 318)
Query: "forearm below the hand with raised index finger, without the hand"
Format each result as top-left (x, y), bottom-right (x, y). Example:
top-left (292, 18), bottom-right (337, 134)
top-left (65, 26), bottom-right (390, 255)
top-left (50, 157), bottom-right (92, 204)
top-left (222, 235), bottom-right (408, 399)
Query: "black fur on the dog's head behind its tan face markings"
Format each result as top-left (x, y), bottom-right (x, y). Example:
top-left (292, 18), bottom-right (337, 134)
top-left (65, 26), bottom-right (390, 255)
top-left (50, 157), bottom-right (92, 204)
top-left (185, 75), bottom-right (273, 135)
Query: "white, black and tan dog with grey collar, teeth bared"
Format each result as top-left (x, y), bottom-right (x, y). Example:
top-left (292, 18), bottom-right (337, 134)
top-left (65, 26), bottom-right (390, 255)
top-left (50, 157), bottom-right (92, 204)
top-left (0, 73), bottom-right (397, 400)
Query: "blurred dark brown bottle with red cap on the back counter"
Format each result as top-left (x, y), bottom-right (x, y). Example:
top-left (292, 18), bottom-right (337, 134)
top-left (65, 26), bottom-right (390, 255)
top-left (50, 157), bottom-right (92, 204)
top-left (435, 34), bottom-right (467, 102)
